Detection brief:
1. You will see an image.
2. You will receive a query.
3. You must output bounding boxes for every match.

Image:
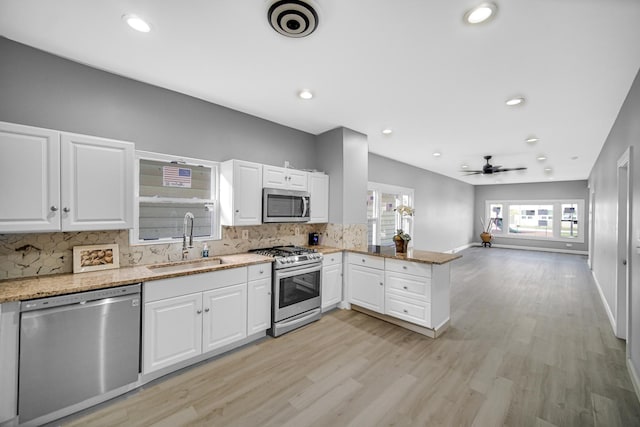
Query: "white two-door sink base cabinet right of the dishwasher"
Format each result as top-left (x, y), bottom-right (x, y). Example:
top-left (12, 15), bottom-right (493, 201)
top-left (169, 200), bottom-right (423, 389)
top-left (142, 267), bottom-right (248, 374)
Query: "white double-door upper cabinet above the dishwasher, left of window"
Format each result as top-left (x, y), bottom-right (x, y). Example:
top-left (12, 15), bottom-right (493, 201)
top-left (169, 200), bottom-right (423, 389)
top-left (0, 122), bottom-right (134, 233)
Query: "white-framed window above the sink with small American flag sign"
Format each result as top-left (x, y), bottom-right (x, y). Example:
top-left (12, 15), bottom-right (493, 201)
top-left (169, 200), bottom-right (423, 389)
top-left (130, 151), bottom-right (220, 244)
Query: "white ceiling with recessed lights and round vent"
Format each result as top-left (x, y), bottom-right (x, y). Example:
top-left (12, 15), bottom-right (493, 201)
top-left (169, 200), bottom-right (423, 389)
top-left (0, 0), bottom-right (640, 185)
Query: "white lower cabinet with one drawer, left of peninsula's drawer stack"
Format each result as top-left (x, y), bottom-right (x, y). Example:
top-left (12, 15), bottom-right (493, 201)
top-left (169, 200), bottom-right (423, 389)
top-left (347, 253), bottom-right (384, 313)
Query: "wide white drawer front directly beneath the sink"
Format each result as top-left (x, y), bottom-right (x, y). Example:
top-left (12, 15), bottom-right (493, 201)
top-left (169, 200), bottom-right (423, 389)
top-left (143, 267), bottom-right (247, 302)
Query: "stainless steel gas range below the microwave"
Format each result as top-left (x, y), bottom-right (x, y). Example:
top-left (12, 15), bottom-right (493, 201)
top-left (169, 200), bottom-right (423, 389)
top-left (251, 246), bottom-right (322, 337)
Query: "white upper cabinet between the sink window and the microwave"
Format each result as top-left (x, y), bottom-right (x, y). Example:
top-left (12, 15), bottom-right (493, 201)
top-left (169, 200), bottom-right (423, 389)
top-left (220, 160), bottom-right (262, 226)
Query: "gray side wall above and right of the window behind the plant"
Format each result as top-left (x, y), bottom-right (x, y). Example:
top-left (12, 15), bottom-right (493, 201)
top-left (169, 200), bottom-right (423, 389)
top-left (369, 153), bottom-right (474, 251)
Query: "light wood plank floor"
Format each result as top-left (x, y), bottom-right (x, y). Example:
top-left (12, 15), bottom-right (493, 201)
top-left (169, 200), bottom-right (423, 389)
top-left (61, 248), bottom-right (640, 427)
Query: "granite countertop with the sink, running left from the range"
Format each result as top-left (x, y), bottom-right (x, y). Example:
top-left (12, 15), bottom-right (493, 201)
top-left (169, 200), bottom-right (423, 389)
top-left (0, 253), bottom-right (273, 303)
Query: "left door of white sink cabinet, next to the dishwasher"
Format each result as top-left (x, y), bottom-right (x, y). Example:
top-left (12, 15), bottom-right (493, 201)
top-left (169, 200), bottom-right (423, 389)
top-left (142, 292), bottom-right (202, 373)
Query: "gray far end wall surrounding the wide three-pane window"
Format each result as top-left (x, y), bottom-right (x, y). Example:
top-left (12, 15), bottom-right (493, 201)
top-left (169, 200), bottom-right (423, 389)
top-left (473, 180), bottom-right (589, 252)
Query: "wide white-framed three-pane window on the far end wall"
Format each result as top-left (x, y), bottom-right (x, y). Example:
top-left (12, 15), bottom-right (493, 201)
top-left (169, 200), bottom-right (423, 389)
top-left (486, 200), bottom-right (584, 242)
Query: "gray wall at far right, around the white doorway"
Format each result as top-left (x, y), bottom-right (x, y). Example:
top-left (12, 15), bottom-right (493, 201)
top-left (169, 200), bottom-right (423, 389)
top-left (589, 68), bottom-right (640, 382)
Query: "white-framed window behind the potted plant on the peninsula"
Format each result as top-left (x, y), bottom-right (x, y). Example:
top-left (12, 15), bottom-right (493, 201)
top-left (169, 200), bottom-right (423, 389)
top-left (367, 182), bottom-right (413, 246)
